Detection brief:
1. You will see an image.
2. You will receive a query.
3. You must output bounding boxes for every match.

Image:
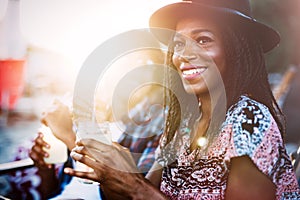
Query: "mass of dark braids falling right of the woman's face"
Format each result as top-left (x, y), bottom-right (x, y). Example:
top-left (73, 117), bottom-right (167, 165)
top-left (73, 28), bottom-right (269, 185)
top-left (223, 28), bottom-right (285, 136)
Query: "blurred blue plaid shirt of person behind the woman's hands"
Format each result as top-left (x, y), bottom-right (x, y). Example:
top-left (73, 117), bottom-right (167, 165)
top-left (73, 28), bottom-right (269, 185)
top-left (118, 100), bottom-right (164, 174)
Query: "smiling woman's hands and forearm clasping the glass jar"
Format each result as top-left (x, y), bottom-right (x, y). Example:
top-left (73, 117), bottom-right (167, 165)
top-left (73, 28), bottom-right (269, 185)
top-left (65, 139), bottom-right (165, 198)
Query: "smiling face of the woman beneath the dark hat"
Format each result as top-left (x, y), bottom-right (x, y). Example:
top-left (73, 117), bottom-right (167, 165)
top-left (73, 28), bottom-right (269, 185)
top-left (172, 17), bottom-right (226, 96)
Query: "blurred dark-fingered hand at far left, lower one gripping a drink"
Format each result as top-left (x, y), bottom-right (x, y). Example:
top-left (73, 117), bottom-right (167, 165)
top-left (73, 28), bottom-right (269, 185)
top-left (29, 132), bottom-right (52, 169)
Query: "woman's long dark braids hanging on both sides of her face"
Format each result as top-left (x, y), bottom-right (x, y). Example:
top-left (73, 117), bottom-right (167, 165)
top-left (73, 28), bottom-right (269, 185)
top-left (163, 22), bottom-right (285, 149)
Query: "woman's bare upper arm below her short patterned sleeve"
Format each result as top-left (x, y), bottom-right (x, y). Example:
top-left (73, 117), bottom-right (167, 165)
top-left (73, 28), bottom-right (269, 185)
top-left (225, 156), bottom-right (276, 200)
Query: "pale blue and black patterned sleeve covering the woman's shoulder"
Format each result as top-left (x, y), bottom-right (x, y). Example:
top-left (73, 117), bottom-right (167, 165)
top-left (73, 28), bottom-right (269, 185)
top-left (223, 96), bottom-right (280, 158)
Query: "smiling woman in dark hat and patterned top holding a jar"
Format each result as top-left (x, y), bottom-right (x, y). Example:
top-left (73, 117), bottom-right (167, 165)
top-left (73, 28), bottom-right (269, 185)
top-left (65, 0), bottom-right (300, 200)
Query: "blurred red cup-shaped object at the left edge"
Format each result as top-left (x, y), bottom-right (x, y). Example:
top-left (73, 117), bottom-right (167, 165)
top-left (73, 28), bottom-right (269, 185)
top-left (0, 59), bottom-right (25, 110)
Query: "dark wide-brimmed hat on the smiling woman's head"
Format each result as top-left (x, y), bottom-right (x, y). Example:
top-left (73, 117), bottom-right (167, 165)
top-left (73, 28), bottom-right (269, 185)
top-left (149, 0), bottom-right (280, 52)
